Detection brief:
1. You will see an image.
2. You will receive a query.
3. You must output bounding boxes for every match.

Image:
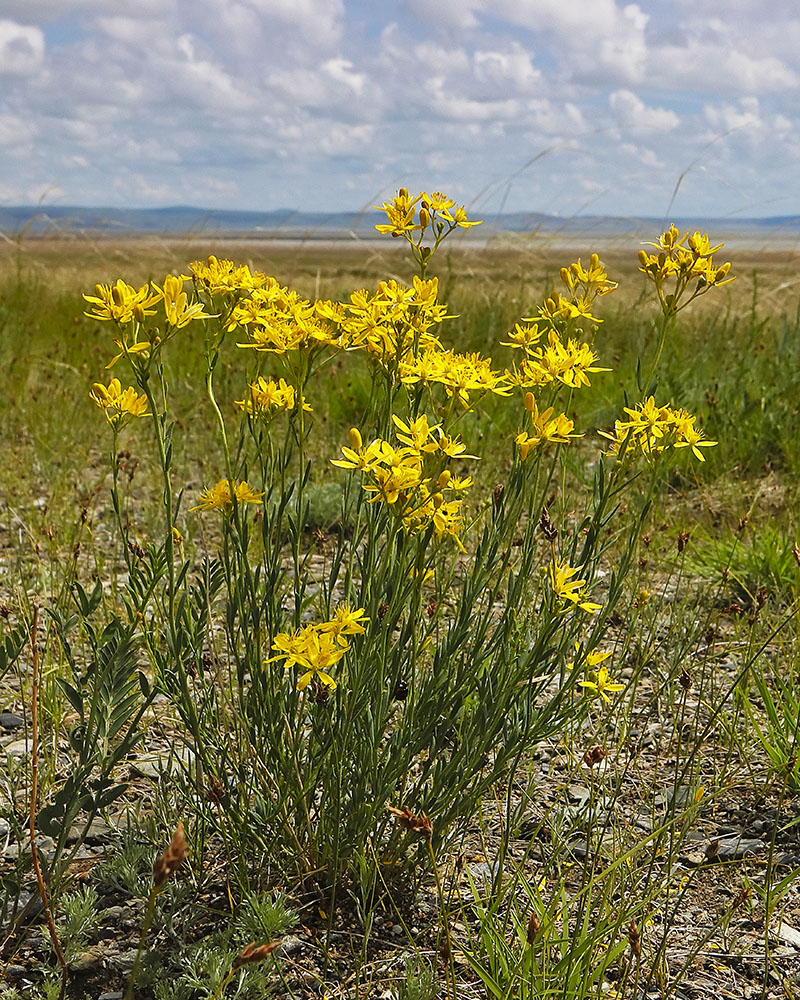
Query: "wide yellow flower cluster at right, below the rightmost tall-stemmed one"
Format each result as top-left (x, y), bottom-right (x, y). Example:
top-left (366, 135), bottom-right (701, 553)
top-left (600, 396), bottom-right (717, 462)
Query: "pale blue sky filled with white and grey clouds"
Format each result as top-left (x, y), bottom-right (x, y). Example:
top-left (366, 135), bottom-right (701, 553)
top-left (0, 0), bottom-right (800, 218)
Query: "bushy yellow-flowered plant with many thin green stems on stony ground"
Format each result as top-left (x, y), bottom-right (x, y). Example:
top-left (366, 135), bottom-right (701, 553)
top-left (84, 191), bottom-right (728, 896)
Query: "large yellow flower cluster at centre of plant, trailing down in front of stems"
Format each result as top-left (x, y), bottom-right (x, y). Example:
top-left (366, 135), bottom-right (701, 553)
top-left (332, 414), bottom-right (475, 552)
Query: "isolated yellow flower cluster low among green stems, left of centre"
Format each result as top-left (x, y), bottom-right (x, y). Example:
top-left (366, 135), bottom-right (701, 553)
top-left (267, 604), bottom-right (369, 691)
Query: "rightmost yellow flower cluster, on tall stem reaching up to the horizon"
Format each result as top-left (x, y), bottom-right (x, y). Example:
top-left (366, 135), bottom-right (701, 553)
top-left (639, 225), bottom-right (734, 316)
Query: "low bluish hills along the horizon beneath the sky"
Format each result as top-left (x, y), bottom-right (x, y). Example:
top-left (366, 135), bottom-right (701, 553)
top-left (0, 205), bottom-right (800, 241)
